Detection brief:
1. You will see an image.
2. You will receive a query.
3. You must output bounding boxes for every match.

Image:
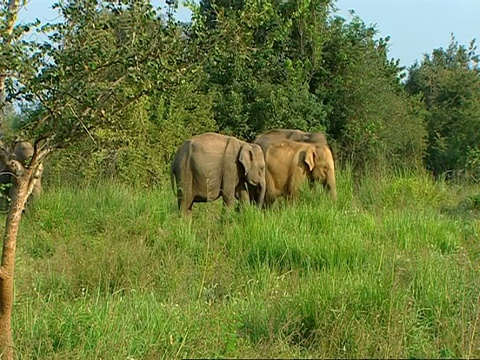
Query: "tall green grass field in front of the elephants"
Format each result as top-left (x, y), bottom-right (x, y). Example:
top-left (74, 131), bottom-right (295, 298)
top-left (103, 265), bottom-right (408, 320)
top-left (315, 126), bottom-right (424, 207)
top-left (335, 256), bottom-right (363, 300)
top-left (2, 169), bottom-right (480, 359)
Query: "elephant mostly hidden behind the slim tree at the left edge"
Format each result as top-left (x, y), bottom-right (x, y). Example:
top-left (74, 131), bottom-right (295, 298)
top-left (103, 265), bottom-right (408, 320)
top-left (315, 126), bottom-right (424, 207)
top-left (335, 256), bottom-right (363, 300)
top-left (0, 141), bottom-right (43, 210)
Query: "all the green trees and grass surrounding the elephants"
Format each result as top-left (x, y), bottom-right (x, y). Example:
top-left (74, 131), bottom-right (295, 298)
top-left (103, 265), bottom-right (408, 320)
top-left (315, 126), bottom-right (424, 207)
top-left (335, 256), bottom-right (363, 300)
top-left (0, 0), bottom-right (480, 359)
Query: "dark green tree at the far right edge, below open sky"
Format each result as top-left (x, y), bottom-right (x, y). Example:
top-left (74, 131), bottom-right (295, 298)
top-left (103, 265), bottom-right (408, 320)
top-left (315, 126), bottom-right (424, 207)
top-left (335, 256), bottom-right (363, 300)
top-left (406, 35), bottom-right (480, 175)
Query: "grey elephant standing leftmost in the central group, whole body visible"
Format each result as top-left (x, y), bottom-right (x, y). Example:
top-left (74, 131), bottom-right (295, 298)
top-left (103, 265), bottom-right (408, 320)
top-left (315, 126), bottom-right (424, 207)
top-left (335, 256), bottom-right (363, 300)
top-left (171, 133), bottom-right (265, 215)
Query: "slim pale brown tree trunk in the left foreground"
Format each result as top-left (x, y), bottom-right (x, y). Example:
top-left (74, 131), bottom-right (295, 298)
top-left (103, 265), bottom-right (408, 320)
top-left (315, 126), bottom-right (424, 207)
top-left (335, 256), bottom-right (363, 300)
top-left (0, 169), bottom-right (32, 360)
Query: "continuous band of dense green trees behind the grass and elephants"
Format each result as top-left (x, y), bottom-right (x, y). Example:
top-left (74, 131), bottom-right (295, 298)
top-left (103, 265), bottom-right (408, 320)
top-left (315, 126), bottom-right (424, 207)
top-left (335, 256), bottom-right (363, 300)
top-left (0, 0), bottom-right (480, 180)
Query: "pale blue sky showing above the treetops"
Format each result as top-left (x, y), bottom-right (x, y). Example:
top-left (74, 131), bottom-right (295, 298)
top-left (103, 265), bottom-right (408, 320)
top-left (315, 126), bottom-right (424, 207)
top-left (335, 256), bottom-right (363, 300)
top-left (15, 0), bottom-right (480, 67)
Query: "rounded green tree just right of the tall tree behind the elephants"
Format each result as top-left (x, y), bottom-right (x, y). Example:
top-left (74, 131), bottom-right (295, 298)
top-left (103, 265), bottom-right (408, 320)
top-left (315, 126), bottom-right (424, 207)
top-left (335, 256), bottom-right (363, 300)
top-left (316, 15), bottom-right (424, 168)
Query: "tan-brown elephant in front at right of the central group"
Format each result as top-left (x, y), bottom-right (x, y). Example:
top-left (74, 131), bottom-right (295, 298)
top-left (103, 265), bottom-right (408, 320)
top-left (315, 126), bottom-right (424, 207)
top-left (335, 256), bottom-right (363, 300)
top-left (265, 140), bottom-right (337, 206)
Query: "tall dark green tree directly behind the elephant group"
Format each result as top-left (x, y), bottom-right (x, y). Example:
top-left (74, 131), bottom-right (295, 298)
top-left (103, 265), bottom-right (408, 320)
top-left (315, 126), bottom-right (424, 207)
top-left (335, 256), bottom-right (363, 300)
top-left (189, 0), bottom-right (331, 140)
